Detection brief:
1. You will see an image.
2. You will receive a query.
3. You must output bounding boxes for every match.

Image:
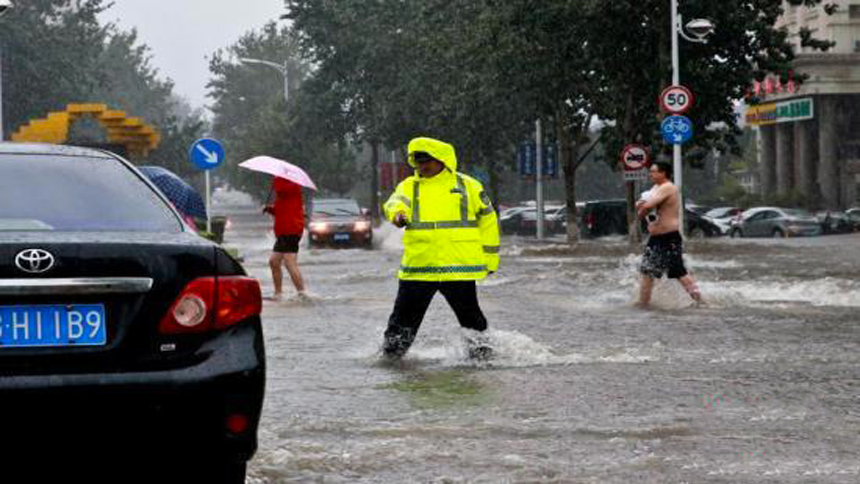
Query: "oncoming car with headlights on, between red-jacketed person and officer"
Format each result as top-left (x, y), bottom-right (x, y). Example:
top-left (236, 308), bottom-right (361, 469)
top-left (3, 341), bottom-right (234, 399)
top-left (308, 198), bottom-right (373, 249)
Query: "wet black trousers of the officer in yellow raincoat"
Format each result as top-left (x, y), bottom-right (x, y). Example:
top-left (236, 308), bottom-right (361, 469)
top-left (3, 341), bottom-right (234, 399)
top-left (382, 280), bottom-right (487, 356)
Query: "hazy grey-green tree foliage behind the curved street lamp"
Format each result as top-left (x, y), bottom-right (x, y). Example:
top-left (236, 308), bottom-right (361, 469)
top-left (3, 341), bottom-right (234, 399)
top-left (208, 23), bottom-right (358, 197)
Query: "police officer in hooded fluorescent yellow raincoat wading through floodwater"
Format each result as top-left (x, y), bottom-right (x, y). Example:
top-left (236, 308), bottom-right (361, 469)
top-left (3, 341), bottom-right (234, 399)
top-left (382, 138), bottom-right (499, 359)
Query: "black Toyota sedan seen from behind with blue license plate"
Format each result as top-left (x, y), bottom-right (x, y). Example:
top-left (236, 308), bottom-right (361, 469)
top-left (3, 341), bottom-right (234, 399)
top-left (0, 143), bottom-right (265, 482)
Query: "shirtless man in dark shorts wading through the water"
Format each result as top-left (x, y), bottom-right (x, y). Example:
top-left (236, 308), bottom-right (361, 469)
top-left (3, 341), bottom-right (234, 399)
top-left (636, 161), bottom-right (702, 308)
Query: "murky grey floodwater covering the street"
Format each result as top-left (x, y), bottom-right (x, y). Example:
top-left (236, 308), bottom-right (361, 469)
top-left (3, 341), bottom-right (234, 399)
top-left (215, 191), bottom-right (860, 484)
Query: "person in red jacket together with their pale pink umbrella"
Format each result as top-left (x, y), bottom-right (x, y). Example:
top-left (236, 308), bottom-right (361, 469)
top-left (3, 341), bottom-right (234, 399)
top-left (239, 156), bottom-right (316, 301)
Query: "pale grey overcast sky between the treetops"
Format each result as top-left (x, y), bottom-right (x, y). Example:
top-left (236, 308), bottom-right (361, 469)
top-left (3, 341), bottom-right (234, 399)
top-left (101, 0), bottom-right (285, 107)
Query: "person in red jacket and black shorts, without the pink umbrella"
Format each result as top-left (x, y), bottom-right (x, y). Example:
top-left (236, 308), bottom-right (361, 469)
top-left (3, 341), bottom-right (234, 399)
top-left (263, 178), bottom-right (305, 300)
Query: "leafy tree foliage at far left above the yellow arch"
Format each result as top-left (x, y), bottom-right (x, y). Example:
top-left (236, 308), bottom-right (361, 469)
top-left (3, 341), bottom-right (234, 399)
top-left (0, 0), bottom-right (204, 174)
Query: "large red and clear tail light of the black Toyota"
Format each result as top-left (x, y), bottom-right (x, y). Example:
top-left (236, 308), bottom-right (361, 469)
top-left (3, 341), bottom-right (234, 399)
top-left (158, 276), bottom-right (263, 334)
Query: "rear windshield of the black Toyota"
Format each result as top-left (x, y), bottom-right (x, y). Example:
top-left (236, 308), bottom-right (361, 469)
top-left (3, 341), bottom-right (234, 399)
top-left (0, 155), bottom-right (182, 232)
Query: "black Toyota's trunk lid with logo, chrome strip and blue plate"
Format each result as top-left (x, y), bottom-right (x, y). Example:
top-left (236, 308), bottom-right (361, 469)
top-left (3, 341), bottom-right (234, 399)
top-left (0, 232), bottom-right (218, 374)
